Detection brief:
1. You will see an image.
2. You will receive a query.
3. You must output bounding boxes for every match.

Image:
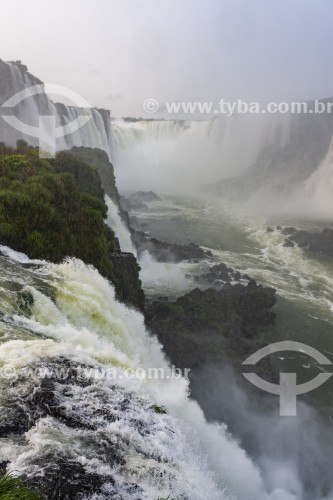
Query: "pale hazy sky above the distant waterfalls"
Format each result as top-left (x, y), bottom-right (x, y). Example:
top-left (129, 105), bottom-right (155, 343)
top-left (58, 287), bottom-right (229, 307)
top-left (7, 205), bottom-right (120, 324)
top-left (0, 0), bottom-right (333, 117)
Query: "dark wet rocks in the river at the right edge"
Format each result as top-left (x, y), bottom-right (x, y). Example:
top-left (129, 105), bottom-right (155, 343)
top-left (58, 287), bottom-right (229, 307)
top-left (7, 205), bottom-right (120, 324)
top-left (286, 229), bottom-right (333, 258)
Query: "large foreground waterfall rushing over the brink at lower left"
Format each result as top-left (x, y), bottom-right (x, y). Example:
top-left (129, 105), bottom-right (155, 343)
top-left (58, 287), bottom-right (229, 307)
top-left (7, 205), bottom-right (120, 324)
top-left (0, 252), bottom-right (281, 500)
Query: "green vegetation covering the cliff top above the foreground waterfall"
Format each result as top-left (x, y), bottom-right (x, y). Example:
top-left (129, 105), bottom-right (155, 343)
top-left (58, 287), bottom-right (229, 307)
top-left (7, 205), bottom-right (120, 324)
top-left (0, 147), bottom-right (117, 278)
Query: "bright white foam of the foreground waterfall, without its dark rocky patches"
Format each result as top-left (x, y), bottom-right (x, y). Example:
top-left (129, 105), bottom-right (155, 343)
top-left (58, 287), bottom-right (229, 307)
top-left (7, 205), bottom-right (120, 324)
top-left (0, 254), bottom-right (287, 500)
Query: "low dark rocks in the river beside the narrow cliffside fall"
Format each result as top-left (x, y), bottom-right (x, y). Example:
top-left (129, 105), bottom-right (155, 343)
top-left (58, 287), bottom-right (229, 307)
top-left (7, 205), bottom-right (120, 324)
top-left (132, 231), bottom-right (212, 262)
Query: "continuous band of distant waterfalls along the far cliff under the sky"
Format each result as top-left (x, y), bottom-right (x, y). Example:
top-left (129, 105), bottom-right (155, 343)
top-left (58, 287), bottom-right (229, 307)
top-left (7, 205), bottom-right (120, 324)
top-left (0, 60), bottom-right (333, 205)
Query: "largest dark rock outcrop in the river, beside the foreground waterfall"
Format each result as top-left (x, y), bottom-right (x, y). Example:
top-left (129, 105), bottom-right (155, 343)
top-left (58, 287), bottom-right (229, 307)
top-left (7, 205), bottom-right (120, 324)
top-left (145, 281), bottom-right (276, 368)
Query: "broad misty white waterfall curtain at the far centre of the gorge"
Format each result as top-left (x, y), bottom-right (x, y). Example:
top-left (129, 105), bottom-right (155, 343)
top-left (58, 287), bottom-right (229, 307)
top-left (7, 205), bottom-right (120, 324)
top-left (112, 115), bottom-right (290, 194)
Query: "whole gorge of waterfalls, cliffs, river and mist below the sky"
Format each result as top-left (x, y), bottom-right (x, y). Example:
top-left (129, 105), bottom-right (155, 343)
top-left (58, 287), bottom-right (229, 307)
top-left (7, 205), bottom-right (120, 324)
top-left (0, 61), bottom-right (333, 500)
